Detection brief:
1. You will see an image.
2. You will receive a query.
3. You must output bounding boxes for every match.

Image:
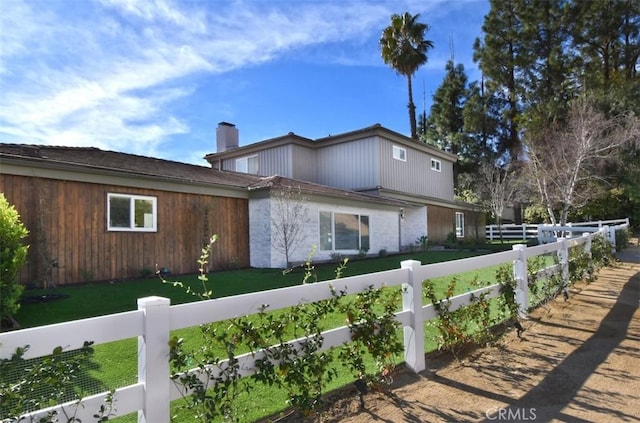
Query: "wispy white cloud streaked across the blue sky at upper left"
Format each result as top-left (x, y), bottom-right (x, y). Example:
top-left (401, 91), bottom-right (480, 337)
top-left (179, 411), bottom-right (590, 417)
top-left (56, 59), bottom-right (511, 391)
top-left (0, 0), bottom-right (482, 161)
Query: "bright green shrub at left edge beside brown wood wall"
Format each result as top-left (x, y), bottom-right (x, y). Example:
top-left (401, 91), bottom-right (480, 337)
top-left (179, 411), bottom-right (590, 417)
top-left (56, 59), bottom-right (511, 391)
top-left (0, 194), bottom-right (29, 326)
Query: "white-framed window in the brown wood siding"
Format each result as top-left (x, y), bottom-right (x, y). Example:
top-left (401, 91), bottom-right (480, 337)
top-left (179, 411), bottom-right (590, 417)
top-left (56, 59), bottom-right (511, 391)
top-left (107, 193), bottom-right (158, 232)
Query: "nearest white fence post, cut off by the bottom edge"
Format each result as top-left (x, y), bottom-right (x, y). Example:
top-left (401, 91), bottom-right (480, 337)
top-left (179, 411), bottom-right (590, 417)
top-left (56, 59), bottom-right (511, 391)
top-left (138, 297), bottom-right (171, 423)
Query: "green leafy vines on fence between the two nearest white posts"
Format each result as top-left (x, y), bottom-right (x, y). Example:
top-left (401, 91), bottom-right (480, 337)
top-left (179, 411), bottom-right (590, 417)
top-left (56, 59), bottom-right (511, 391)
top-left (168, 237), bottom-right (403, 422)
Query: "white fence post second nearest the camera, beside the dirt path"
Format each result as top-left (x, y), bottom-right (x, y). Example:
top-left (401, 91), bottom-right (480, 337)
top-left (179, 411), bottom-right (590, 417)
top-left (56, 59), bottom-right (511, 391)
top-left (400, 260), bottom-right (426, 373)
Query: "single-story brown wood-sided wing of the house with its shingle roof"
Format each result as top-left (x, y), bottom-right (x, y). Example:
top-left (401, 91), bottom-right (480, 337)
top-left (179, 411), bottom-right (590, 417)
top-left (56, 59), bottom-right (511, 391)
top-left (0, 144), bottom-right (260, 287)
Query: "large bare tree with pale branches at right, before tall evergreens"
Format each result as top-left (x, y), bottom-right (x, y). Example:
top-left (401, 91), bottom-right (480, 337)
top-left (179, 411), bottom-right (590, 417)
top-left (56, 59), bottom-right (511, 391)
top-left (527, 97), bottom-right (639, 226)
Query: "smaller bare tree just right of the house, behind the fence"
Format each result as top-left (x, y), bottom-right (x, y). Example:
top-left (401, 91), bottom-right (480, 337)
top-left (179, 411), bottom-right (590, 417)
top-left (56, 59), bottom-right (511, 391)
top-left (478, 161), bottom-right (518, 242)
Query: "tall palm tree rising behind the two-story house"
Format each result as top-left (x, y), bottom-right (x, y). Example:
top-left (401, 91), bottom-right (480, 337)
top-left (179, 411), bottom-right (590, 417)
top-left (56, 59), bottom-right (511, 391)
top-left (380, 12), bottom-right (433, 139)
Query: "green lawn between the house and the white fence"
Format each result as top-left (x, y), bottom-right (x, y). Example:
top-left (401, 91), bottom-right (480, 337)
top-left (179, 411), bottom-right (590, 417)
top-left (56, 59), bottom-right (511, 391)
top-left (10, 247), bottom-right (528, 422)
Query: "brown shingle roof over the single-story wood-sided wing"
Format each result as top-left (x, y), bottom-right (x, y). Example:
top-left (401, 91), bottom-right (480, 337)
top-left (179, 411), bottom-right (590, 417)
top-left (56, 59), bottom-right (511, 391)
top-left (0, 143), bottom-right (260, 187)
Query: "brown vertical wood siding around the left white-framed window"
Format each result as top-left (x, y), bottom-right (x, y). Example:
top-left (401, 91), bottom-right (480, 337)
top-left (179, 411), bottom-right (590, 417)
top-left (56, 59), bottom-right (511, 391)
top-left (0, 174), bottom-right (249, 286)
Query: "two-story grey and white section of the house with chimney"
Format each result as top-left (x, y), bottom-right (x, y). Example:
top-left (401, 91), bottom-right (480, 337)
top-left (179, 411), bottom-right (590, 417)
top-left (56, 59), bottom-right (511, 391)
top-left (205, 122), bottom-right (484, 267)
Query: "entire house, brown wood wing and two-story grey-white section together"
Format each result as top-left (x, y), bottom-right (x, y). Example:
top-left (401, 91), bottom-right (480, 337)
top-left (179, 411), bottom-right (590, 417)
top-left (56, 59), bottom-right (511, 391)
top-left (0, 122), bottom-right (484, 286)
